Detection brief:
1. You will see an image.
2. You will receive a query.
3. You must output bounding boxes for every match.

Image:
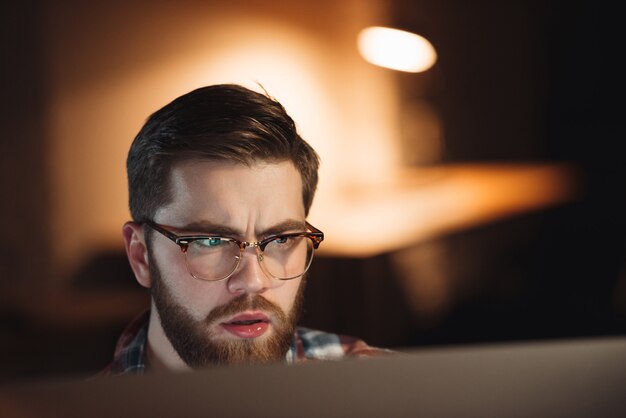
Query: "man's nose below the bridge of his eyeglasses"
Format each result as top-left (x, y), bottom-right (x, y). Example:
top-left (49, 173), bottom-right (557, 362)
top-left (228, 248), bottom-right (273, 295)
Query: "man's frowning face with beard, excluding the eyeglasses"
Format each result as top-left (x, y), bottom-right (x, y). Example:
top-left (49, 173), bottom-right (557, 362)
top-left (150, 161), bottom-right (312, 368)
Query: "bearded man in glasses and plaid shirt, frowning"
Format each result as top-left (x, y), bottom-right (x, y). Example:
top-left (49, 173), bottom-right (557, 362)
top-left (103, 85), bottom-right (386, 374)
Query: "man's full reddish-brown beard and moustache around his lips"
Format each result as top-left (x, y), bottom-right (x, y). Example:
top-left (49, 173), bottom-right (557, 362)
top-left (150, 262), bottom-right (306, 369)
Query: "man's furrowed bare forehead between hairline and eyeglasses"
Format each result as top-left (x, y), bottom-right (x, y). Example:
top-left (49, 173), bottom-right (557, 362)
top-left (157, 160), bottom-right (304, 231)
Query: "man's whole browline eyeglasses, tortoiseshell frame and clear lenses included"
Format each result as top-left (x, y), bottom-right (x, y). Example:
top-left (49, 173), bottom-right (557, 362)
top-left (145, 221), bottom-right (324, 281)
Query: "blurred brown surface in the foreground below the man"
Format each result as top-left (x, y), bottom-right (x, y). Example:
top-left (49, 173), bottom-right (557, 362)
top-left (0, 337), bottom-right (626, 418)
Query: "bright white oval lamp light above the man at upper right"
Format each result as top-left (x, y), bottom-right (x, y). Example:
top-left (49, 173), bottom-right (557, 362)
top-left (358, 26), bottom-right (437, 73)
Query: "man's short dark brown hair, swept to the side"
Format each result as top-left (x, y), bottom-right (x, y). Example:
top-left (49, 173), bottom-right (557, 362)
top-left (126, 84), bottom-right (319, 222)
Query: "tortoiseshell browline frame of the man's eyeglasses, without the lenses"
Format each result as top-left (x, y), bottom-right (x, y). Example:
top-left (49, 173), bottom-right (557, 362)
top-left (143, 219), bottom-right (324, 282)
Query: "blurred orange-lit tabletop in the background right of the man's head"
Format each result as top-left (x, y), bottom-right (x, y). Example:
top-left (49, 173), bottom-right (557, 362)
top-left (309, 163), bottom-right (581, 257)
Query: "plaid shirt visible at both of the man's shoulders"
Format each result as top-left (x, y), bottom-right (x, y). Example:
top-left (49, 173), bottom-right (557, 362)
top-left (100, 311), bottom-right (392, 375)
